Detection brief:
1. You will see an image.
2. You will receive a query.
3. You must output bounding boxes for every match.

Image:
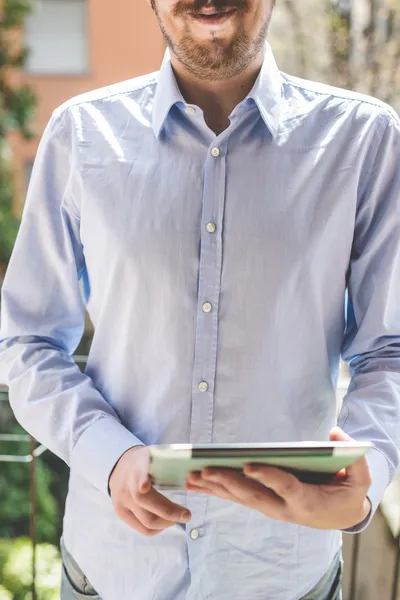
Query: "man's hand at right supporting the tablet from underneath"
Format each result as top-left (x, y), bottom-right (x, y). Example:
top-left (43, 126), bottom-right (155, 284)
top-left (185, 427), bottom-right (371, 529)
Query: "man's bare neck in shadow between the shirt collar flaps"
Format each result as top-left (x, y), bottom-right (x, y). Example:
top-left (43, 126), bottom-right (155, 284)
top-left (171, 50), bottom-right (265, 135)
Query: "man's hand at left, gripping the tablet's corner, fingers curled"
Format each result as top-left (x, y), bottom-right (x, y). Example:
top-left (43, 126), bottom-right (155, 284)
top-left (109, 446), bottom-right (191, 537)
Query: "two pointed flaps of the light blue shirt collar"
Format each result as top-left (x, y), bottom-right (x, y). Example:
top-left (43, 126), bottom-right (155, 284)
top-left (152, 44), bottom-right (282, 139)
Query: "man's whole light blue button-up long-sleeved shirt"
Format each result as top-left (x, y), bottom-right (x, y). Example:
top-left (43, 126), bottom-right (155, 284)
top-left (0, 48), bottom-right (400, 600)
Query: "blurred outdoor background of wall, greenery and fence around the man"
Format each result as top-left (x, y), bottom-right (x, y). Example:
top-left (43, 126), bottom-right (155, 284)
top-left (0, 0), bottom-right (400, 600)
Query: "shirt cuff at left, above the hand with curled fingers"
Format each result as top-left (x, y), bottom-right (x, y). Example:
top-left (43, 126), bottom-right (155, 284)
top-left (70, 417), bottom-right (143, 496)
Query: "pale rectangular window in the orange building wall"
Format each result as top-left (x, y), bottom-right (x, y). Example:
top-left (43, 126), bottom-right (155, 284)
top-left (25, 0), bottom-right (88, 75)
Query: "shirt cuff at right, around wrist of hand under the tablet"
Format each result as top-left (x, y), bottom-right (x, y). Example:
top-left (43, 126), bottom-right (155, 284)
top-left (343, 448), bottom-right (390, 533)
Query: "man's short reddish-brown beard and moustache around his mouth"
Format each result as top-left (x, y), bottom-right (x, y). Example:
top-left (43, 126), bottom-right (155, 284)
top-left (151, 0), bottom-right (275, 81)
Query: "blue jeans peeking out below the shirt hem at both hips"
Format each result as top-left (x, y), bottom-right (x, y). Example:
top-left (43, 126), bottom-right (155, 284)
top-left (60, 539), bottom-right (342, 600)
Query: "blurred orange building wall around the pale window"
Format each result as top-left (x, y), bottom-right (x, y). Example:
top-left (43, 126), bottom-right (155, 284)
top-left (12, 0), bottom-right (165, 213)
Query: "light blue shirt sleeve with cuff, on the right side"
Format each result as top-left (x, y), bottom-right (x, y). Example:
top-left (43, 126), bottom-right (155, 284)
top-left (339, 114), bottom-right (400, 533)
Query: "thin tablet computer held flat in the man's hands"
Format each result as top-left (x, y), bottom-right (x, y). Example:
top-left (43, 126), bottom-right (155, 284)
top-left (148, 441), bottom-right (372, 490)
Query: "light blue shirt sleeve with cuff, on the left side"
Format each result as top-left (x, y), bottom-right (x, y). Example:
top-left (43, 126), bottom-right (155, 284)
top-left (0, 111), bottom-right (141, 494)
